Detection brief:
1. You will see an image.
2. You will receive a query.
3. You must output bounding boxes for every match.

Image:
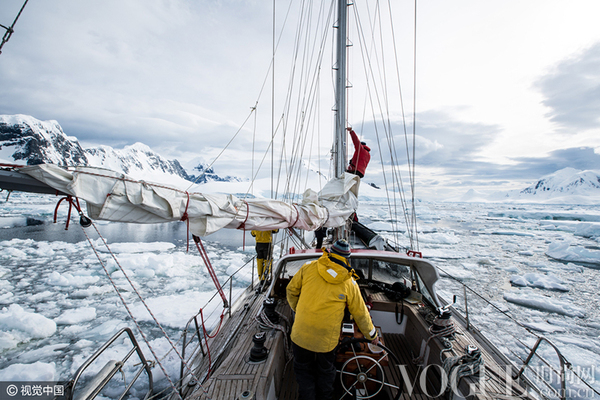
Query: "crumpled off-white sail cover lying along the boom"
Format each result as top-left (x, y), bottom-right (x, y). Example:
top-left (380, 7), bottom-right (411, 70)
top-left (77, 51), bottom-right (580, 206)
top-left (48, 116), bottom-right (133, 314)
top-left (19, 164), bottom-right (360, 236)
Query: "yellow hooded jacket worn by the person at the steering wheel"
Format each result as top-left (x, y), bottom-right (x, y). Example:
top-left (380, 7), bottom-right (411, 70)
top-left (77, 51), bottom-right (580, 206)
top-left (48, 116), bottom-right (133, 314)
top-left (287, 252), bottom-right (377, 353)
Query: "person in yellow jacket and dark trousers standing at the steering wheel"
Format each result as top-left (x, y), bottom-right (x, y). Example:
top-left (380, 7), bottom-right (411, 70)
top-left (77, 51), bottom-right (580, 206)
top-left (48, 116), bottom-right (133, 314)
top-left (287, 239), bottom-right (379, 400)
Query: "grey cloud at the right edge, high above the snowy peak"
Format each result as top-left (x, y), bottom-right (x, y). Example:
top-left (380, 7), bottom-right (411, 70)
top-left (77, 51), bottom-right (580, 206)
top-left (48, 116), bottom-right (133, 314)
top-left (535, 43), bottom-right (600, 133)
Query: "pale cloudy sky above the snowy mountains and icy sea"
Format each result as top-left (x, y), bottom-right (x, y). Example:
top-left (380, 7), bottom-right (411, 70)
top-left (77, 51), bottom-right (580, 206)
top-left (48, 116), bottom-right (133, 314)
top-left (0, 0), bottom-right (600, 200)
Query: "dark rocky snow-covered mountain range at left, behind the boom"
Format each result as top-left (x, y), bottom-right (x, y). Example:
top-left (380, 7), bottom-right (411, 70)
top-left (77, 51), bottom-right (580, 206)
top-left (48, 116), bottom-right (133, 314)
top-left (0, 115), bottom-right (237, 183)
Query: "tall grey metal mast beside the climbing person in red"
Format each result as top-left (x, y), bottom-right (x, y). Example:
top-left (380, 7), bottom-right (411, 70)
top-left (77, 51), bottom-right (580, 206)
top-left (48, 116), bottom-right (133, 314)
top-left (333, 0), bottom-right (348, 240)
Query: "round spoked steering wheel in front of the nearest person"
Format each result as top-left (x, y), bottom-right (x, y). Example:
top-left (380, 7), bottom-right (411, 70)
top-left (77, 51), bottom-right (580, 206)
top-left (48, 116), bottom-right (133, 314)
top-left (336, 338), bottom-right (402, 400)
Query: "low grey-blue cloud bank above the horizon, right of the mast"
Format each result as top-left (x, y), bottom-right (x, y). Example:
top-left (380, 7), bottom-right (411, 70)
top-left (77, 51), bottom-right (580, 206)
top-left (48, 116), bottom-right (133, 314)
top-left (362, 111), bottom-right (600, 191)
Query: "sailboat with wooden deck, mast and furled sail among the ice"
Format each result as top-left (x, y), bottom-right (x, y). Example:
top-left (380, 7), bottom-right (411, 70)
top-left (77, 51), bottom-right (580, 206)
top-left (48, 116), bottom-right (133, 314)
top-left (0, 0), bottom-right (592, 400)
